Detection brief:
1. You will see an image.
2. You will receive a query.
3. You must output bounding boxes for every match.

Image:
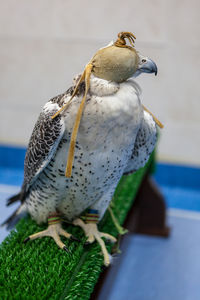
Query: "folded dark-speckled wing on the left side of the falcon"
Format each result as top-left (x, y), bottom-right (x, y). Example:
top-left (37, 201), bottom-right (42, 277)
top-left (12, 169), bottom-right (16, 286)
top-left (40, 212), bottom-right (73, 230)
top-left (23, 101), bottom-right (65, 191)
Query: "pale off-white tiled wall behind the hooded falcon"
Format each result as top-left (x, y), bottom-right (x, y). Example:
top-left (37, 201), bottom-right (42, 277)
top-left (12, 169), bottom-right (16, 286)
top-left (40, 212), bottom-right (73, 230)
top-left (0, 0), bottom-right (200, 165)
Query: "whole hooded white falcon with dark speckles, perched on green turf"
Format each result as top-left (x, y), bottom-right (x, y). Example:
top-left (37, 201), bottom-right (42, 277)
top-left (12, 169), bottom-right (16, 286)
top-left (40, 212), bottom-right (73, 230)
top-left (4, 32), bottom-right (160, 266)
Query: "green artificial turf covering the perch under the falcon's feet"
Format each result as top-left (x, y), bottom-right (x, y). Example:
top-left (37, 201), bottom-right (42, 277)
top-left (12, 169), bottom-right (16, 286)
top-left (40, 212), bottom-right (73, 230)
top-left (0, 161), bottom-right (151, 300)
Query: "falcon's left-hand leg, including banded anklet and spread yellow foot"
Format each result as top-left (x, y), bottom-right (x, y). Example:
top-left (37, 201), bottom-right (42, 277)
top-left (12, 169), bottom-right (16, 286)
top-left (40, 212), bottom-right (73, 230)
top-left (24, 213), bottom-right (78, 252)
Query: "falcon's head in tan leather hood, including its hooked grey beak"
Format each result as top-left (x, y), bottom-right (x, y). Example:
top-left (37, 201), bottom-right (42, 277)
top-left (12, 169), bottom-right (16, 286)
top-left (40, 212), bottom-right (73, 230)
top-left (90, 32), bottom-right (158, 82)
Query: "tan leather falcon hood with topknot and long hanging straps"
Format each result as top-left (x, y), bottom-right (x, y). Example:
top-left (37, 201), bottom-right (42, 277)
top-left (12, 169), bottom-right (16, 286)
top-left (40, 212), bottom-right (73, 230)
top-left (52, 32), bottom-right (163, 177)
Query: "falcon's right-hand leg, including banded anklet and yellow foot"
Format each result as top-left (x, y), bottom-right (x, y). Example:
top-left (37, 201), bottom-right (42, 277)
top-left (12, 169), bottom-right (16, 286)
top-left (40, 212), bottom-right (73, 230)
top-left (73, 209), bottom-right (117, 266)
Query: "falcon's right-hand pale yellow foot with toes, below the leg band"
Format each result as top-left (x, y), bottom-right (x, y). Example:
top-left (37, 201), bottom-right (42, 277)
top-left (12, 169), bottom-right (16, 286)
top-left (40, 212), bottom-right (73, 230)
top-left (73, 219), bottom-right (117, 266)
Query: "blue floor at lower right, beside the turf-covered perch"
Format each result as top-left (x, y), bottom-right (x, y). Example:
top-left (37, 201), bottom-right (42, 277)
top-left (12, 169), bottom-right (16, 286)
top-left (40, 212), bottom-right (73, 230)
top-left (98, 217), bottom-right (200, 300)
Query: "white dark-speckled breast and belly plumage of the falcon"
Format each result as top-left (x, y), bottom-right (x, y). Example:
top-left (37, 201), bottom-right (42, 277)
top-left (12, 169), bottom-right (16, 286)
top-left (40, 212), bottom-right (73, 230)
top-left (24, 76), bottom-right (156, 223)
